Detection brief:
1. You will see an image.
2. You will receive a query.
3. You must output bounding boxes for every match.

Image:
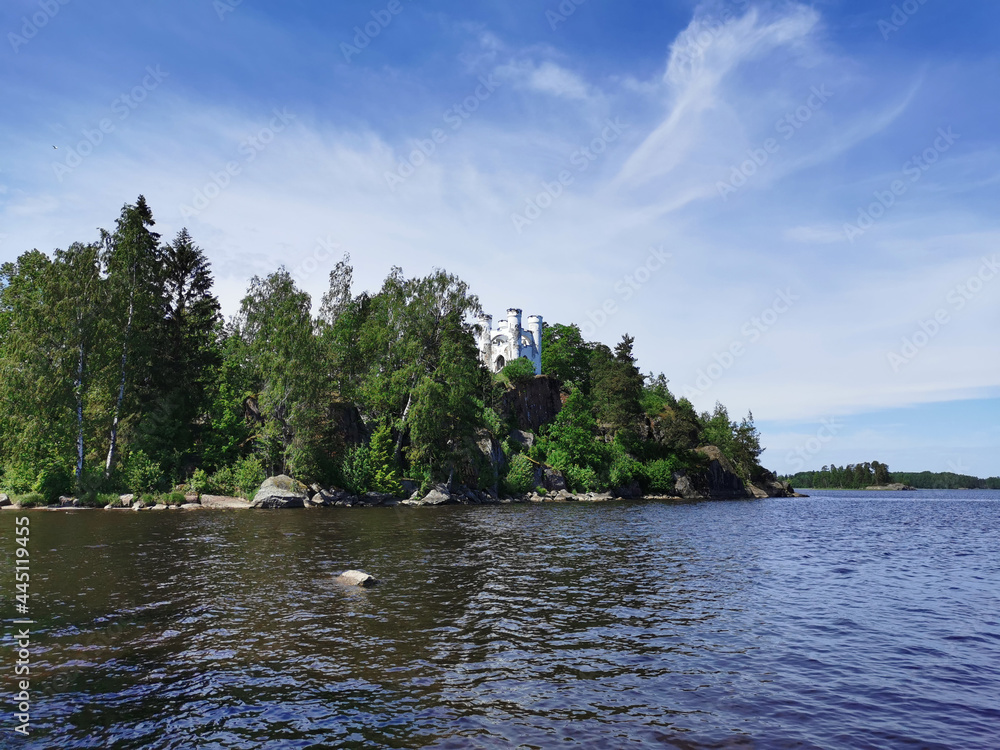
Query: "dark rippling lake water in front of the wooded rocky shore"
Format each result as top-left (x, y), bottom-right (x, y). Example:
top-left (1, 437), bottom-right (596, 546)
top-left (0, 491), bottom-right (1000, 749)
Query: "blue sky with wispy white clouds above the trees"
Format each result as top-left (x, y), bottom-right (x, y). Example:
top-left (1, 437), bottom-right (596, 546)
top-left (0, 0), bottom-right (1000, 476)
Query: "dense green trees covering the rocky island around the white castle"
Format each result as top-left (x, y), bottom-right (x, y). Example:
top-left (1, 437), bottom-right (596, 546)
top-left (0, 196), bottom-right (761, 508)
